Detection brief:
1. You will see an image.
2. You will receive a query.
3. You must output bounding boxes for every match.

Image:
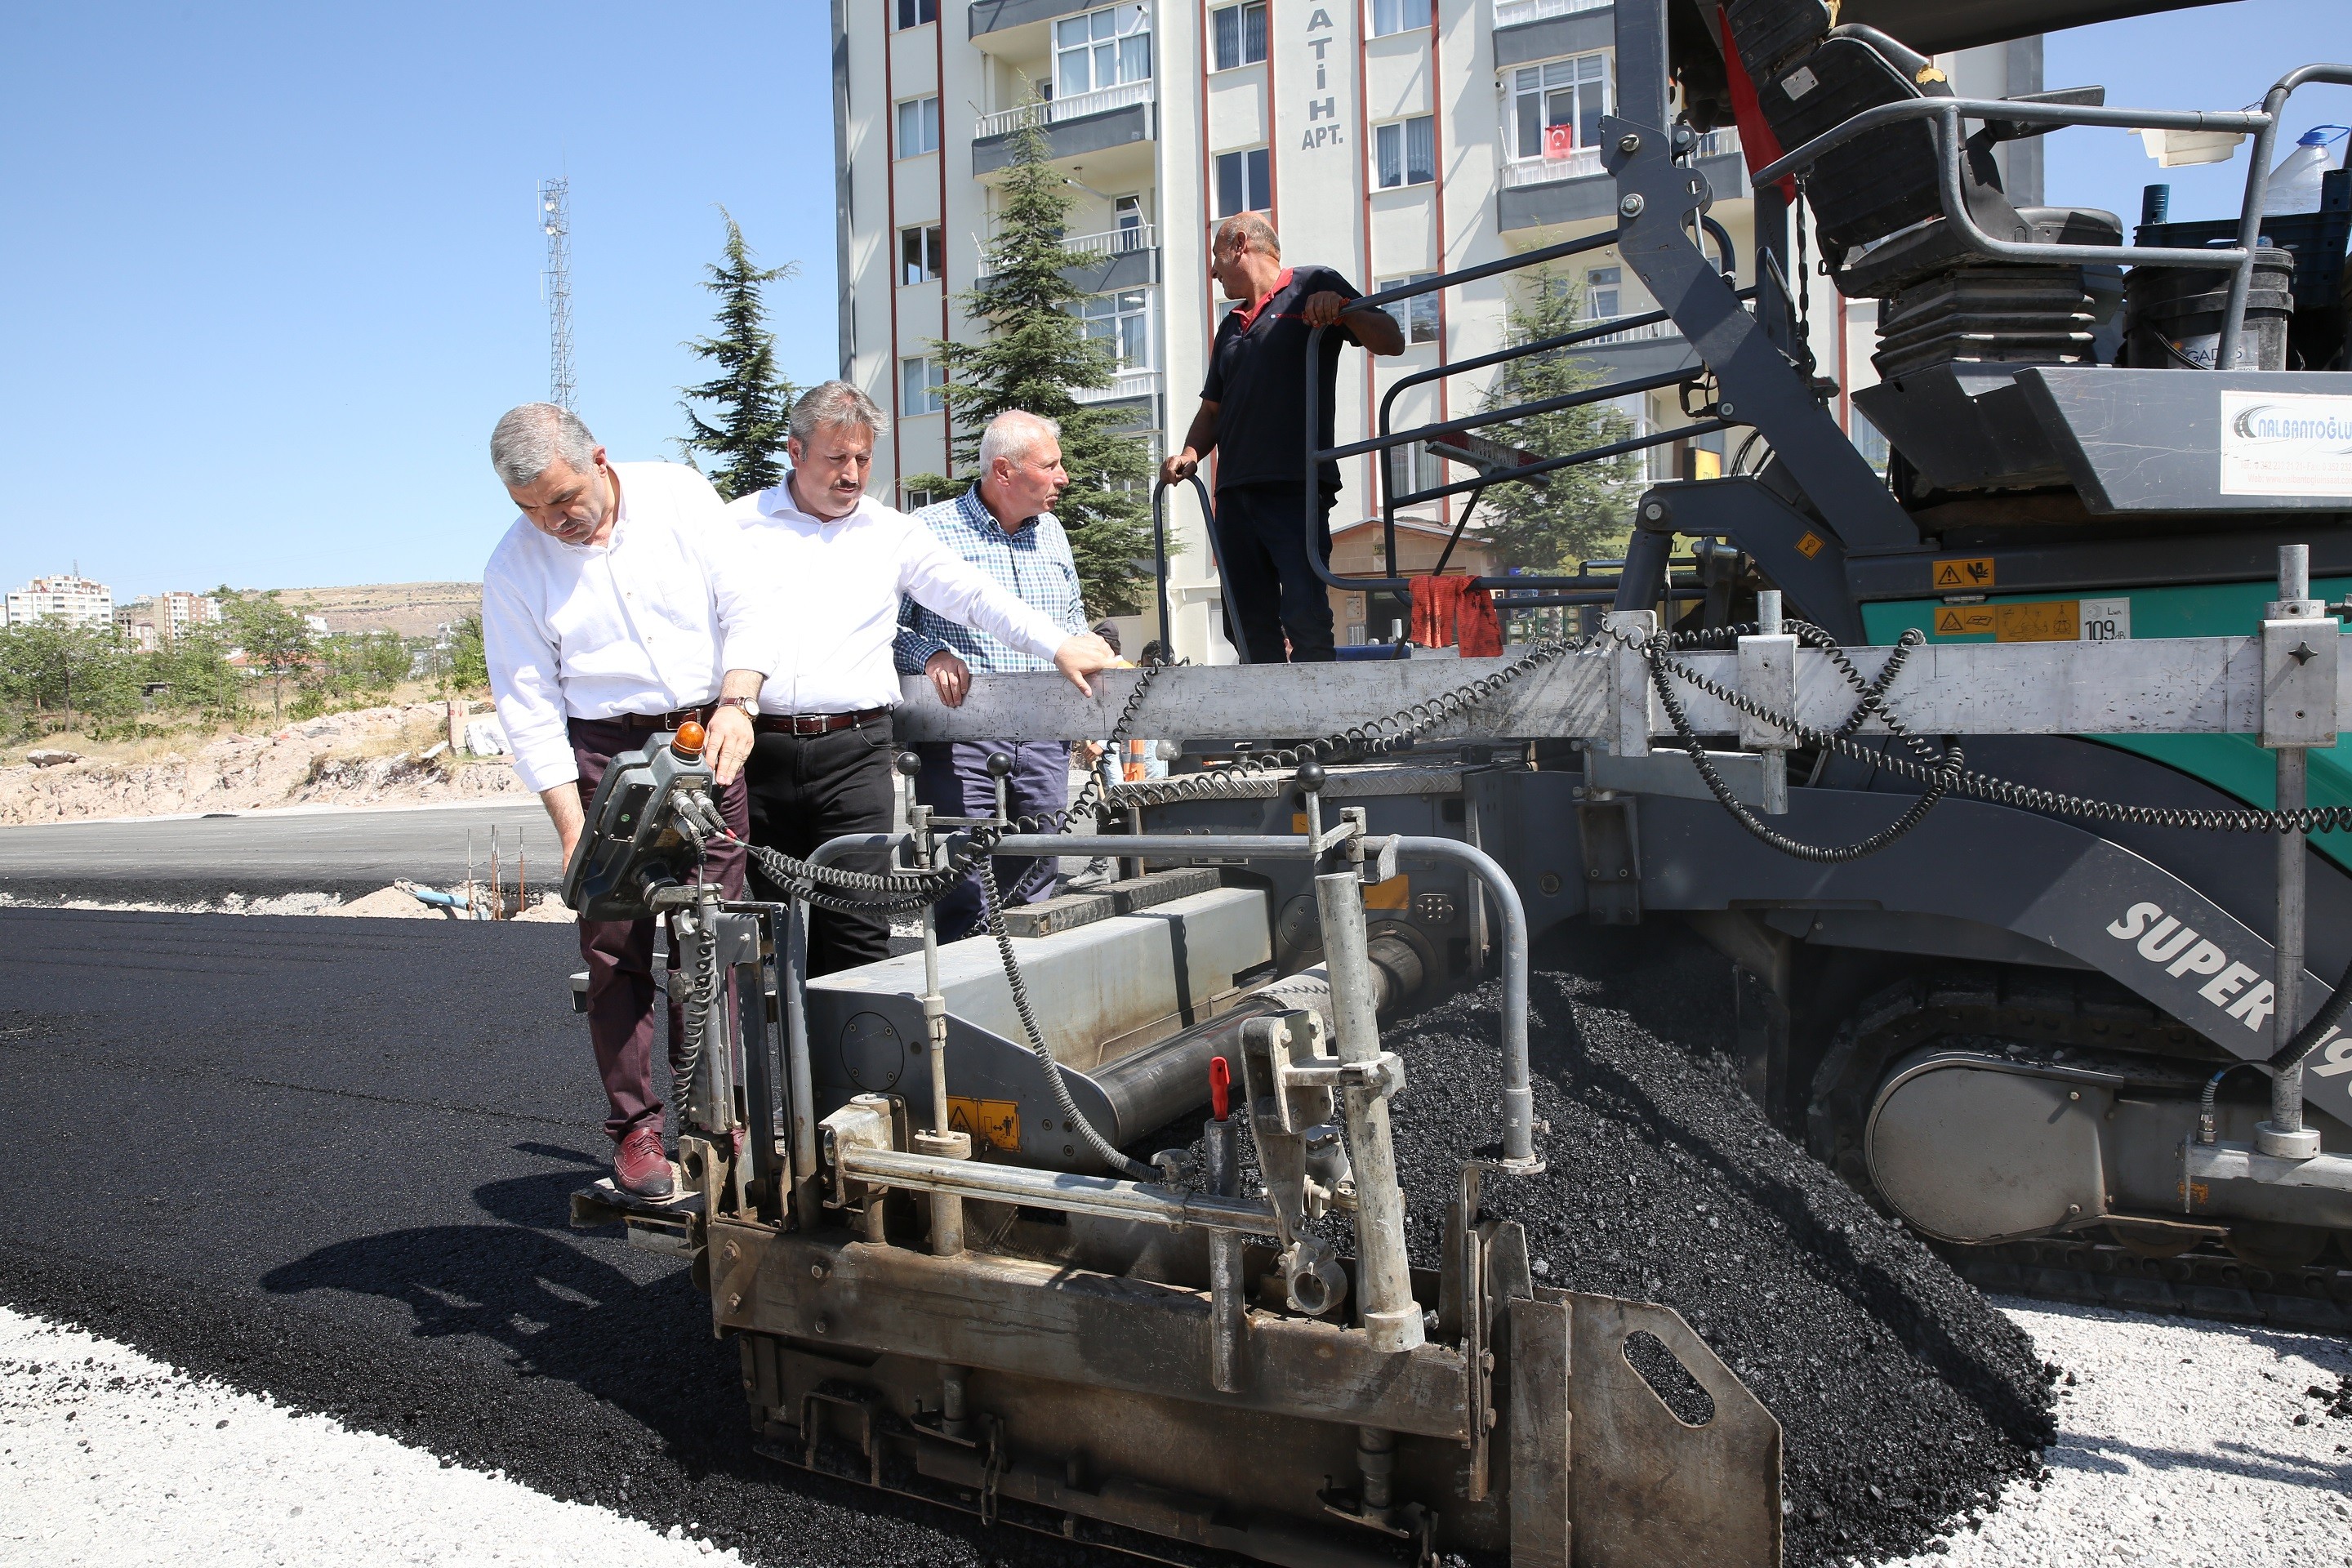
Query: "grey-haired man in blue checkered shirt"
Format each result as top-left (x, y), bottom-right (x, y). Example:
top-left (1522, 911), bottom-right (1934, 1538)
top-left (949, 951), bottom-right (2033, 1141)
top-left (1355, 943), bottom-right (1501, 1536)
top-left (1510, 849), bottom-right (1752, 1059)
top-left (896, 412), bottom-right (1087, 940)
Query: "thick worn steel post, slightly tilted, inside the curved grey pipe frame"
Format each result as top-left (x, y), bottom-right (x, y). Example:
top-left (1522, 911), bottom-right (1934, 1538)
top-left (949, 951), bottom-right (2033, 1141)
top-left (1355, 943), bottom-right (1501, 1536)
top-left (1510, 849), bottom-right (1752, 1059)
top-left (1315, 870), bottom-right (1425, 1352)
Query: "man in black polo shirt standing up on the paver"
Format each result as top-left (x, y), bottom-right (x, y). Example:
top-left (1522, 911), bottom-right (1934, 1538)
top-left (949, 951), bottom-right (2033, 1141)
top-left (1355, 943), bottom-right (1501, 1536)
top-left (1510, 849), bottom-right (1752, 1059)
top-left (1160, 212), bottom-right (1404, 666)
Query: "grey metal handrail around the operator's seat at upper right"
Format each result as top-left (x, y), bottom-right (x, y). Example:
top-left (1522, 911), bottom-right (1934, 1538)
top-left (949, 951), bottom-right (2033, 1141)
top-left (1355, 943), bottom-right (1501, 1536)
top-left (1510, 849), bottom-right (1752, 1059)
top-left (1754, 66), bottom-right (2352, 369)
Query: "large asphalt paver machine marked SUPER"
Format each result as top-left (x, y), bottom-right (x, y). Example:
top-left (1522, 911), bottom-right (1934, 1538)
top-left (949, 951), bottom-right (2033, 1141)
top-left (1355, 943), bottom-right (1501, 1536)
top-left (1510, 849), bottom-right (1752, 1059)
top-left (564, 0), bottom-right (2352, 1568)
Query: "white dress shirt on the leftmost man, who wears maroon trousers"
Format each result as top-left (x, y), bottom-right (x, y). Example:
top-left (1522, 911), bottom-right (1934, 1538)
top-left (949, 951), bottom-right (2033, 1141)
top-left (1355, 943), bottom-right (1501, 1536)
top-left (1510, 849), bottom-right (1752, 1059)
top-left (482, 463), bottom-right (776, 790)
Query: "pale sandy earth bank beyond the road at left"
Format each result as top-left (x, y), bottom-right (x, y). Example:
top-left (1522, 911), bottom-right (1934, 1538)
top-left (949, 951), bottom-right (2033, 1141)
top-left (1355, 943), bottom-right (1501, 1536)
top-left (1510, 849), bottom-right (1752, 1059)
top-left (0, 701), bottom-right (522, 825)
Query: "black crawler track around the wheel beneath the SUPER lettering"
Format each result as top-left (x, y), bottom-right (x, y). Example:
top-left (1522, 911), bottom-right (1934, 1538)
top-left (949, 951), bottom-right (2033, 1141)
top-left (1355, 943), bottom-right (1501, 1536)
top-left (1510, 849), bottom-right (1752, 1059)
top-left (1806, 964), bottom-right (2352, 1333)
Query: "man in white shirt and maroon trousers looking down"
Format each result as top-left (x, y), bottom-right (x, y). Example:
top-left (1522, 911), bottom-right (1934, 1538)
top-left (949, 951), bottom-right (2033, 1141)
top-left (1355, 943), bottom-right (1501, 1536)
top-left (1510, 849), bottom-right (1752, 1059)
top-left (482, 402), bottom-right (776, 1196)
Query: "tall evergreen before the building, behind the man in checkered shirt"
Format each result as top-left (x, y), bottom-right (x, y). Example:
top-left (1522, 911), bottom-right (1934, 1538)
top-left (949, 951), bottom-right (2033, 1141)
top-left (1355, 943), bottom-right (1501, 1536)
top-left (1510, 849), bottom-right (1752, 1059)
top-left (906, 107), bottom-right (1152, 616)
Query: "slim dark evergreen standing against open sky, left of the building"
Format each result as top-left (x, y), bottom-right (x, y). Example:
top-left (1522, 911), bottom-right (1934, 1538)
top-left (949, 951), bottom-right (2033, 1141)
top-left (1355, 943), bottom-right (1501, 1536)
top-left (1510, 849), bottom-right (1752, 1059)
top-left (677, 207), bottom-right (800, 501)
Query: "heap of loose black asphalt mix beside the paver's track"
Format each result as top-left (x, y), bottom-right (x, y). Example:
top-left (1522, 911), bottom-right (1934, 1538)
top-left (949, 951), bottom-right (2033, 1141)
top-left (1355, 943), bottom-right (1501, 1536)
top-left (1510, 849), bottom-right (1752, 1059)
top-left (1388, 929), bottom-right (2053, 1568)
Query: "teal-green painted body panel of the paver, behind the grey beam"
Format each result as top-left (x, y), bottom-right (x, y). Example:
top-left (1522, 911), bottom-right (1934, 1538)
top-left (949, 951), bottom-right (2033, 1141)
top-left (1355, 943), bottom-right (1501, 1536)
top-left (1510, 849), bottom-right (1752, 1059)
top-left (1863, 578), bottom-right (2352, 870)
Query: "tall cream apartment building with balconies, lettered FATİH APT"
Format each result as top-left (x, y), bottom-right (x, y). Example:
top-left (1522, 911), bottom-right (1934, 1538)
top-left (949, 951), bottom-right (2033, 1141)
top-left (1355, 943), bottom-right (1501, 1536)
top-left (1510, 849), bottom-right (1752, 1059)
top-left (833, 0), bottom-right (2042, 661)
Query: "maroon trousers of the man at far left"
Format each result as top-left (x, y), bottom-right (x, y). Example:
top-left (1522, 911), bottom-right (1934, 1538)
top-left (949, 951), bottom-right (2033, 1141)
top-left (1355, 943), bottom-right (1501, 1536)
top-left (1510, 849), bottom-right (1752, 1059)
top-left (572, 719), bottom-right (751, 1143)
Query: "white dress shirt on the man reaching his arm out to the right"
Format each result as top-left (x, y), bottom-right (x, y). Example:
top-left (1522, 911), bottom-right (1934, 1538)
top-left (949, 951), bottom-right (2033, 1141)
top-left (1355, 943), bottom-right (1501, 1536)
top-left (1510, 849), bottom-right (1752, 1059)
top-left (727, 477), bottom-right (1070, 712)
